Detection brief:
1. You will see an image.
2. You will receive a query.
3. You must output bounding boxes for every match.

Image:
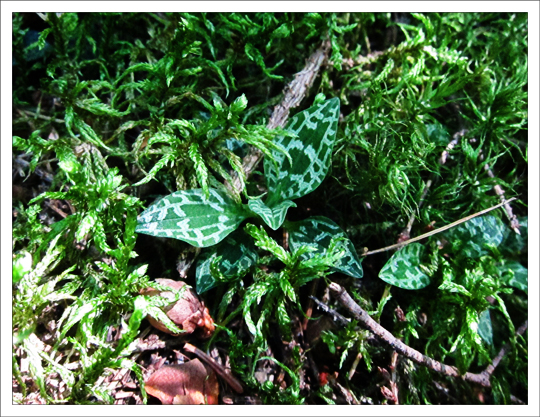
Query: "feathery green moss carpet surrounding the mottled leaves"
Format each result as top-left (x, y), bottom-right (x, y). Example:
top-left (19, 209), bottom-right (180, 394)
top-left (12, 13), bottom-right (528, 404)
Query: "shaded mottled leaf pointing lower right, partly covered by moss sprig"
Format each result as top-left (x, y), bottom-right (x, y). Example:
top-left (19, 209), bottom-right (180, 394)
top-left (287, 216), bottom-right (364, 278)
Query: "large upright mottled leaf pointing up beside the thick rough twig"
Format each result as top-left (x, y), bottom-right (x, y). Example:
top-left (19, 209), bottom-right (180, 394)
top-left (264, 98), bottom-right (339, 206)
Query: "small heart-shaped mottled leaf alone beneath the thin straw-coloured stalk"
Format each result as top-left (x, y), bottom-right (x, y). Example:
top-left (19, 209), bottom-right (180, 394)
top-left (379, 243), bottom-right (430, 290)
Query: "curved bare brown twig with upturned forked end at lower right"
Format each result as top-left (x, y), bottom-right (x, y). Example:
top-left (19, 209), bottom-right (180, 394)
top-left (313, 282), bottom-right (527, 388)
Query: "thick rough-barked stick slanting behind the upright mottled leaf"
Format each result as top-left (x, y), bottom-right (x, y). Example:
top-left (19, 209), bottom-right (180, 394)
top-left (233, 40), bottom-right (330, 191)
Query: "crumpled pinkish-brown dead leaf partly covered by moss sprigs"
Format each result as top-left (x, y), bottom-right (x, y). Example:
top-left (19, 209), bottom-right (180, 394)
top-left (142, 278), bottom-right (214, 338)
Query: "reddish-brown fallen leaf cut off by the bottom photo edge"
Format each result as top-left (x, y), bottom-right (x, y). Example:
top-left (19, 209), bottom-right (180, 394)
top-left (145, 359), bottom-right (219, 405)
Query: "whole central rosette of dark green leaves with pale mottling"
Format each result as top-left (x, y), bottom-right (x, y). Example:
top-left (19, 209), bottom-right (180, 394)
top-left (136, 98), bottom-right (363, 293)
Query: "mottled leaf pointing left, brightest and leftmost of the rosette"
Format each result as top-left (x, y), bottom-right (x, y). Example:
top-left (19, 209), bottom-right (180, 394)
top-left (135, 189), bottom-right (249, 247)
